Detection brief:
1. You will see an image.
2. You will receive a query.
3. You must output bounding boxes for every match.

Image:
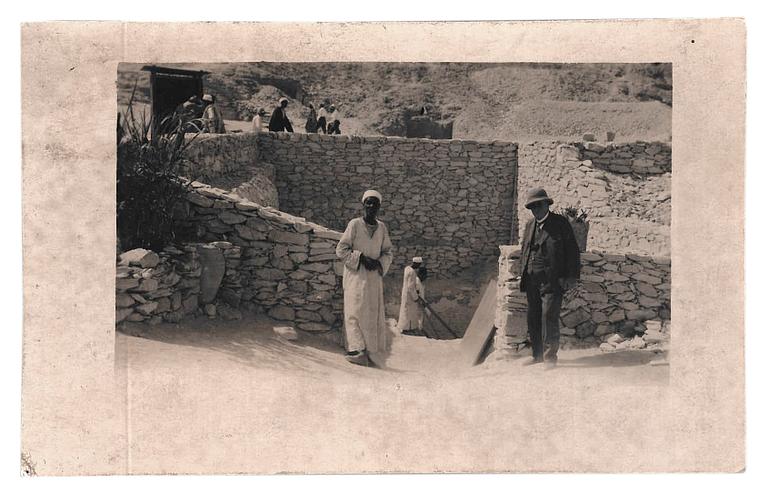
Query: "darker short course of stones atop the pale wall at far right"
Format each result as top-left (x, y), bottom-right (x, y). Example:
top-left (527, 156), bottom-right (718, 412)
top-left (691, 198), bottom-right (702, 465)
top-left (573, 142), bottom-right (672, 175)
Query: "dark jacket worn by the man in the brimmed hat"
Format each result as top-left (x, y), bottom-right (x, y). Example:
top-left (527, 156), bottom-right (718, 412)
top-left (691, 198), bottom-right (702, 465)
top-left (520, 212), bottom-right (581, 291)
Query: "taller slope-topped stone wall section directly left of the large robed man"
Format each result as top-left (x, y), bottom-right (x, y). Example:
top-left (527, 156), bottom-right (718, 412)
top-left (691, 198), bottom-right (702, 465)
top-left (180, 182), bottom-right (343, 332)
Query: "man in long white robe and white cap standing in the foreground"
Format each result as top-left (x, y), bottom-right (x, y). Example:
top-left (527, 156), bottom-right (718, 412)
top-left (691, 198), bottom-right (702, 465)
top-left (336, 190), bottom-right (392, 366)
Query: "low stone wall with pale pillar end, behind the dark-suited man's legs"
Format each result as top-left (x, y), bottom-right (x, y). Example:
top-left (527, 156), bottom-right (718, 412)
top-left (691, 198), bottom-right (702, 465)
top-left (495, 245), bottom-right (671, 348)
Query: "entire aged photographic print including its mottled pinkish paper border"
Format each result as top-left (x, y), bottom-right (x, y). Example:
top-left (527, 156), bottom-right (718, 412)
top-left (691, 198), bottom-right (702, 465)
top-left (22, 20), bottom-right (744, 475)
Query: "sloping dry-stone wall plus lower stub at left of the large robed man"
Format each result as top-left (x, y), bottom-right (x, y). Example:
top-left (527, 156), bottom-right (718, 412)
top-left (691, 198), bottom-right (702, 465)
top-left (117, 182), bottom-right (343, 332)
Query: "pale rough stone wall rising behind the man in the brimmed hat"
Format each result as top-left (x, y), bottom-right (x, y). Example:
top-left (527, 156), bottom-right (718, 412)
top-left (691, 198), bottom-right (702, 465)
top-left (509, 138), bottom-right (672, 256)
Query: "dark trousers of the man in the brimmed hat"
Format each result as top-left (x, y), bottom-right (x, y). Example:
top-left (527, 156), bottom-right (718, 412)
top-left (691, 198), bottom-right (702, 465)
top-left (525, 273), bottom-right (563, 359)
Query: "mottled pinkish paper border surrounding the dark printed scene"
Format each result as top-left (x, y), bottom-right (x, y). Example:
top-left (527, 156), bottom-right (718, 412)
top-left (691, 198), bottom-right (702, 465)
top-left (21, 19), bottom-right (745, 475)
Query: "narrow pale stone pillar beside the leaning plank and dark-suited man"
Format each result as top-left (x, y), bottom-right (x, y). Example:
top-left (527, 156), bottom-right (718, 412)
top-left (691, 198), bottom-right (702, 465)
top-left (492, 245), bottom-right (528, 359)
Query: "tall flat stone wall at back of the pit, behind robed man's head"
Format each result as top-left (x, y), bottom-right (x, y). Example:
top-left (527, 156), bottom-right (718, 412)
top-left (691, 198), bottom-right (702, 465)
top-left (259, 133), bottom-right (517, 277)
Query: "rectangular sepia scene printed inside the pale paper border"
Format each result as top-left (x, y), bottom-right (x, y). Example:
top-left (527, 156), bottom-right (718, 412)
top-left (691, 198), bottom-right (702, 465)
top-left (116, 63), bottom-right (673, 372)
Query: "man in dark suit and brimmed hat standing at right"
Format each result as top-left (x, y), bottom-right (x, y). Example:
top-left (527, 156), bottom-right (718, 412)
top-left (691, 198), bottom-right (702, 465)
top-left (520, 188), bottom-right (581, 363)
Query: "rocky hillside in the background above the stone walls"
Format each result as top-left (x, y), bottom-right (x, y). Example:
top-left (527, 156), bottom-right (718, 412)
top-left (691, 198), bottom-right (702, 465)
top-left (117, 62), bottom-right (672, 141)
